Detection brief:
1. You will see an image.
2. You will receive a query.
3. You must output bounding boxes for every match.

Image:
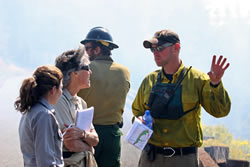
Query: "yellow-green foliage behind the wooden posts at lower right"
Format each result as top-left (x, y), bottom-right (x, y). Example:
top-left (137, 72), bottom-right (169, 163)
top-left (203, 125), bottom-right (250, 161)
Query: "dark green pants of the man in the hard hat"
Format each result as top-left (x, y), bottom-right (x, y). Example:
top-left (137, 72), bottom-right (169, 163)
top-left (94, 125), bottom-right (122, 167)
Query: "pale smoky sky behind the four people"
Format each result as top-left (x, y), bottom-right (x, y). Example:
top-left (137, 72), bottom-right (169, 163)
top-left (0, 0), bottom-right (250, 139)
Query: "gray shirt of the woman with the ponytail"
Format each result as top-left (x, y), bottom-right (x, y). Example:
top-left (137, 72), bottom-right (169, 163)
top-left (19, 99), bottom-right (63, 167)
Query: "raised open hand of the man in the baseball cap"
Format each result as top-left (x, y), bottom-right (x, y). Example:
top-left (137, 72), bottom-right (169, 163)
top-left (207, 55), bottom-right (230, 85)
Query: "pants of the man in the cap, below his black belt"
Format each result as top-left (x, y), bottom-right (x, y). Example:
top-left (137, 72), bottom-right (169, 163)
top-left (138, 150), bottom-right (198, 167)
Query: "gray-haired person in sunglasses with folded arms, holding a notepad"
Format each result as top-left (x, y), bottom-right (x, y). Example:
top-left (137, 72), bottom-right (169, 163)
top-left (54, 46), bottom-right (99, 167)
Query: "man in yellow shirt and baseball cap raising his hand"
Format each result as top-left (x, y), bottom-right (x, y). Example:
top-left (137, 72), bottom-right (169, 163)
top-left (132, 30), bottom-right (231, 167)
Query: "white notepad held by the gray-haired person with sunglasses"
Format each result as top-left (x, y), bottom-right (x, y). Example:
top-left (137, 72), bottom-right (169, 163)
top-left (76, 107), bottom-right (94, 131)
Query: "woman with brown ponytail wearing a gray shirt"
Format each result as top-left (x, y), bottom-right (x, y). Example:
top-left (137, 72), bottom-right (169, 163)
top-left (15, 66), bottom-right (63, 167)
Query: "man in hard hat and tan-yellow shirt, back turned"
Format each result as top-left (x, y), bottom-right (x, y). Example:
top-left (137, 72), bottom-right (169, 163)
top-left (78, 27), bottom-right (130, 167)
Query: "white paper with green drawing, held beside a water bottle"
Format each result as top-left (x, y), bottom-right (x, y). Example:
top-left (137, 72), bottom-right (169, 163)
top-left (125, 118), bottom-right (153, 150)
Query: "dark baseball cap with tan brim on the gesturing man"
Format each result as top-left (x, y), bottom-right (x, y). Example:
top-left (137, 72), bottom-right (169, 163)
top-left (143, 30), bottom-right (180, 48)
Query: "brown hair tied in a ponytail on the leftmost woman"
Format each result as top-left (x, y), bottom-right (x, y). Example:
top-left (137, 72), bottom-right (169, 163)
top-left (14, 65), bottom-right (63, 113)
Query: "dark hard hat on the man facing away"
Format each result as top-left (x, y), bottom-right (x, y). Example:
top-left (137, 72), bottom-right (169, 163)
top-left (81, 27), bottom-right (119, 49)
